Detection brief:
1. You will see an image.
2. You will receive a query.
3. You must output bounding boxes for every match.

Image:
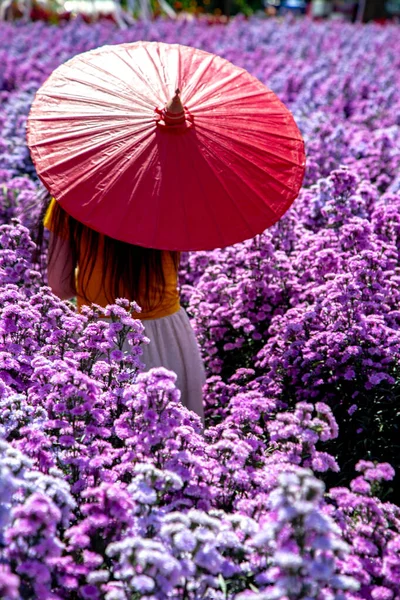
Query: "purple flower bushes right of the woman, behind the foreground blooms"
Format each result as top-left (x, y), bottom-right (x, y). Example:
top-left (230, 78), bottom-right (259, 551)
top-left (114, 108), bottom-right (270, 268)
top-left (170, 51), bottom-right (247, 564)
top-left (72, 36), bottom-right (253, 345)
top-left (182, 167), bottom-right (400, 499)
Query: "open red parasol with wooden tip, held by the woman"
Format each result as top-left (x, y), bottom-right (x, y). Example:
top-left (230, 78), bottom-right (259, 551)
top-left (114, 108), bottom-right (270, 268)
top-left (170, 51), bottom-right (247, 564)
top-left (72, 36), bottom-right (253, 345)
top-left (28, 42), bottom-right (305, 250)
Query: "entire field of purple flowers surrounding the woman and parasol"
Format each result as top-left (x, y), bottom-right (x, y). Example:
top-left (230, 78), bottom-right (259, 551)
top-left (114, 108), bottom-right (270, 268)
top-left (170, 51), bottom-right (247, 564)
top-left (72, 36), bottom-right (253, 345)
top-left (0, 17), bottom-right (400, 600)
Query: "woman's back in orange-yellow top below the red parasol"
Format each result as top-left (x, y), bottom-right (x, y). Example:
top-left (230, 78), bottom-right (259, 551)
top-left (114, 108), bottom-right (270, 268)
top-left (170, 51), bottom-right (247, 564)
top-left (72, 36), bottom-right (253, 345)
top-left (44, 199), bottom-right (180, 320)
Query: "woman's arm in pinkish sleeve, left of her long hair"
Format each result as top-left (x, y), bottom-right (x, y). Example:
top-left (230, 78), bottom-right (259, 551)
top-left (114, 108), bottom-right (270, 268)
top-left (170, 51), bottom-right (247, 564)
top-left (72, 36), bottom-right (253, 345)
top-left (47, 232), bottom-right (76, 300)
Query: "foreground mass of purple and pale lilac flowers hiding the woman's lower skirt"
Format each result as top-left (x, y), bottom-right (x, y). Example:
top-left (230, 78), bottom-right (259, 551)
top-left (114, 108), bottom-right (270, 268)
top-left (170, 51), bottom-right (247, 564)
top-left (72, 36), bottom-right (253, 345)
top-left (0, 218), bottom-right (400, 600)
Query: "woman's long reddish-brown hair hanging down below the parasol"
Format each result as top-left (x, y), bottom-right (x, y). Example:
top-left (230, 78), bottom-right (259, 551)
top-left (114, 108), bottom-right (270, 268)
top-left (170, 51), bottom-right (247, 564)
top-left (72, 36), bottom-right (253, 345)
top-left (37, 192), bottom-right (180, 311)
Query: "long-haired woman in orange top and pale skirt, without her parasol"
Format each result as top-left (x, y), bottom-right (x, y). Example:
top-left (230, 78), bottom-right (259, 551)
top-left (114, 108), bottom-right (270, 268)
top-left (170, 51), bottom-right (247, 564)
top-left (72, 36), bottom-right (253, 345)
top-left (43, 198), bottom-right (205, 424)
